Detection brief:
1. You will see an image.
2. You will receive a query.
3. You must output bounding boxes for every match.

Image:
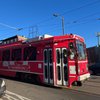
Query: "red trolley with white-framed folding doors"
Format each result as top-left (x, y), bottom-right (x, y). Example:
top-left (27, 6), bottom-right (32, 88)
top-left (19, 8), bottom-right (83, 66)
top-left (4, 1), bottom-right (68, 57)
top-left (0, 34), bottom-right (90, 87)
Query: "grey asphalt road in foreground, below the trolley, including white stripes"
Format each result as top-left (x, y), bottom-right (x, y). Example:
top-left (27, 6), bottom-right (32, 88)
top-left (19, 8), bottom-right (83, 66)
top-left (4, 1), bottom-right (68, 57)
top-left (0, 76), bottom-right (100, 100)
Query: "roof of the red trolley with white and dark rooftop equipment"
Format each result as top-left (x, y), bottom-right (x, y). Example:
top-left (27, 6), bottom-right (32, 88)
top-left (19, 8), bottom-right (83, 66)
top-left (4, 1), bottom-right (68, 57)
top-left (0, 34), bottom-right (84, 48)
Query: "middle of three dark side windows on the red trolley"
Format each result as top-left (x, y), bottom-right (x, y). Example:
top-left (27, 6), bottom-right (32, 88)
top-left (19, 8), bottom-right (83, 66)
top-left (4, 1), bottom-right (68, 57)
top-left (12, 48), bottom-right (22, 61)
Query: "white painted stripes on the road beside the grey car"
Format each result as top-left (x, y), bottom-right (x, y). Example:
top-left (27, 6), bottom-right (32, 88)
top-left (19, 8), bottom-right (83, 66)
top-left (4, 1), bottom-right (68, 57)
top-left (0, 90), bottom-right (31, 100)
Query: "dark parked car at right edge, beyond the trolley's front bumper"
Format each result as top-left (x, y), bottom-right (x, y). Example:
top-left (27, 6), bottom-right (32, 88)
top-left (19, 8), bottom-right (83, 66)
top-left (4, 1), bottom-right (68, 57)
top-left (89, 63), bottom-right (100, 75)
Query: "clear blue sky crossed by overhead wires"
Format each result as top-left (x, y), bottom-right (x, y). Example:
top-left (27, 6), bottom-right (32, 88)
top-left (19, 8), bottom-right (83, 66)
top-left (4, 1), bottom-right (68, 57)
top-left (0, 0), bottom-right (100, 47)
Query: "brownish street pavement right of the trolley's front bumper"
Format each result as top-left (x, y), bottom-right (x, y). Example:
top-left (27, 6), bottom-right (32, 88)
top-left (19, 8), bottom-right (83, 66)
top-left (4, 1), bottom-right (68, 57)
top-left (72, 76), bottom-right (100, 95)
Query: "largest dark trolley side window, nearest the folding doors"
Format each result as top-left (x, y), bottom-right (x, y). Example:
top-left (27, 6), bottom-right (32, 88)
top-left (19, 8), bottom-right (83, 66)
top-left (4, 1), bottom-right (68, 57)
top-left (24, 47), bottom-right (37, 61)
